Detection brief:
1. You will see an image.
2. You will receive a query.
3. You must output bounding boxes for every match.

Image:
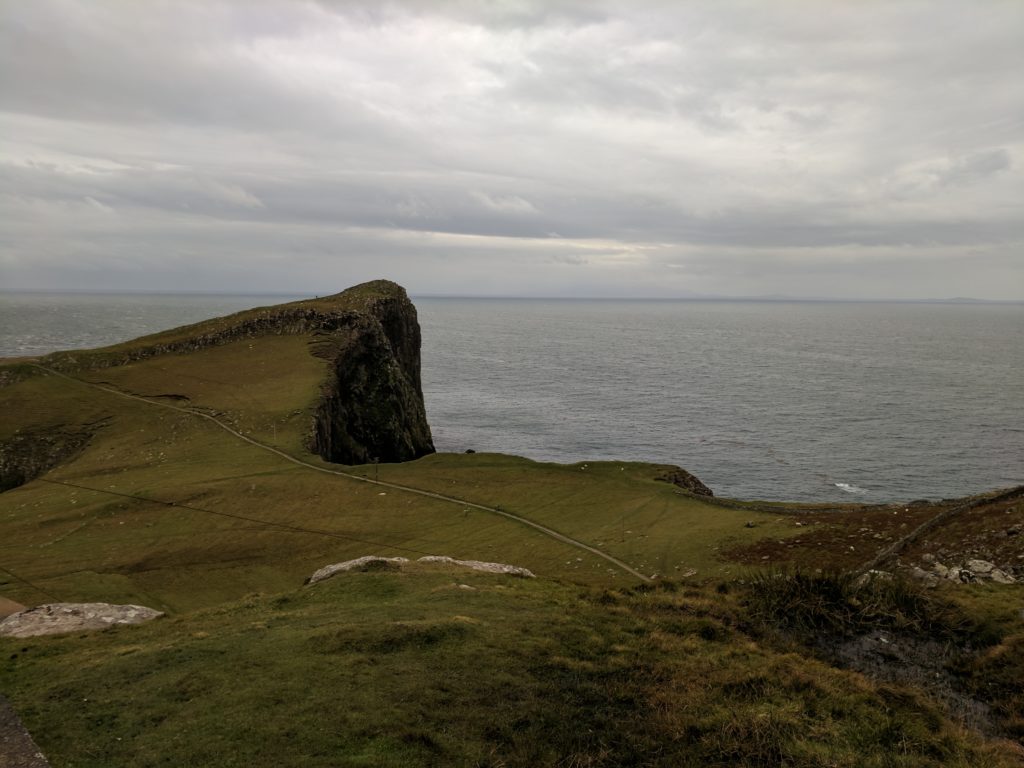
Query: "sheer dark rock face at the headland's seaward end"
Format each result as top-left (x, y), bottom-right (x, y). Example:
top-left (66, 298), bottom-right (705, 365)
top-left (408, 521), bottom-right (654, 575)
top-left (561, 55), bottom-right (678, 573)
top-left (309, 281), bottom-right (434, 464)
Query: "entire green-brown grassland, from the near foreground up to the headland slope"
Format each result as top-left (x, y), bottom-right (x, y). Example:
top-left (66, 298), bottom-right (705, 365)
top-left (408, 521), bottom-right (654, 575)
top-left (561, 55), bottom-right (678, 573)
top-left (0, 294), bottom-right (1024, 766)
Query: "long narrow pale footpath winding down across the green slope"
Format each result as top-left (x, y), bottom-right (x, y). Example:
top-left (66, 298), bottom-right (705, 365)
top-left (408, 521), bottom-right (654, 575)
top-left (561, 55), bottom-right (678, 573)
top-left (36, 365), bottom-right (650, 582)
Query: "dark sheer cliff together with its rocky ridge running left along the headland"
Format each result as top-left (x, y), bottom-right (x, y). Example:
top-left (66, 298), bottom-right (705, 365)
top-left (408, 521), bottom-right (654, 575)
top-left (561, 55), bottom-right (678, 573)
top-left (20, 280), bottom-right (434, 468)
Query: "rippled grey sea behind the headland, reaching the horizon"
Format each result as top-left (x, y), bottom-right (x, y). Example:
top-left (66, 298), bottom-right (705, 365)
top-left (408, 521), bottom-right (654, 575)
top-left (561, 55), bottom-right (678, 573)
top-left (0, 293), bottom-right (1024, 503)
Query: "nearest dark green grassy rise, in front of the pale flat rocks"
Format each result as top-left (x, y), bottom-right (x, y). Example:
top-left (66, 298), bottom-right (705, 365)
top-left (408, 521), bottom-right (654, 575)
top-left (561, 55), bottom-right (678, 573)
top-left (0, 566), bottom-right (1020, 768)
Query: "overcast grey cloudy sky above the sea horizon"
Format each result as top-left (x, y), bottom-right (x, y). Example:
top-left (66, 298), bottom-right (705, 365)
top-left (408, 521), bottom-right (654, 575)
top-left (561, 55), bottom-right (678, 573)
top-left (0, 0), bottom-right (1024, 300)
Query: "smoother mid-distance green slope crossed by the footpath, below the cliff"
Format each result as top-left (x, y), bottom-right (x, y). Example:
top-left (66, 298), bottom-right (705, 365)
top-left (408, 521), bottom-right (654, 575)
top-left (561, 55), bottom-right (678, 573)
top-left (0, 327), bottom-right (794, 609)
